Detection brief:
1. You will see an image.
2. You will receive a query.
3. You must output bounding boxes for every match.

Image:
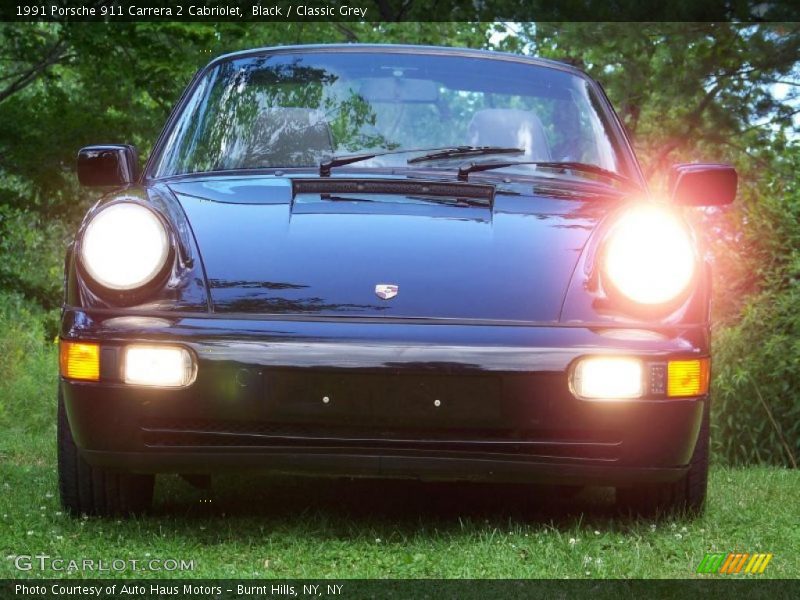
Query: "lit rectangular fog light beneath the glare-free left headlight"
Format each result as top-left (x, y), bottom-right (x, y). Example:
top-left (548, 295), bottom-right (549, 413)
top-left (123, 346), bottom-right (195, 387)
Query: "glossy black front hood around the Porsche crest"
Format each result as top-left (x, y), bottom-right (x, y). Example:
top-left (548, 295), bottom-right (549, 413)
top-left (169, 176), bottom-right (614, 322)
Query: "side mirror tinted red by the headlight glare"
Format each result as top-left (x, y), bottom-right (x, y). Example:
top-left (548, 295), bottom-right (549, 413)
top-left (669, 163), bottom-right (738, 206)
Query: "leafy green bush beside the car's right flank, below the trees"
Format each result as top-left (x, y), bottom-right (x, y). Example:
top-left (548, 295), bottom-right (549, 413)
top-left (712, 146), bottom-right (800, 466)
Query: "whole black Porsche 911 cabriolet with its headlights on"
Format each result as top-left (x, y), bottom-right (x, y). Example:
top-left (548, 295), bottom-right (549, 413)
top-left (58, 45), bottom-right (736, 515)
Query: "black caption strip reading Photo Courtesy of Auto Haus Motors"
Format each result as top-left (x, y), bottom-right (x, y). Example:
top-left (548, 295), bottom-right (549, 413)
top-left (0, 576), bottom-right (800, 600)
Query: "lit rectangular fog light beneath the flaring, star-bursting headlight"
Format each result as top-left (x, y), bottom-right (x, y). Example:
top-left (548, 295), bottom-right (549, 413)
top-left (572, 356), bottom-right (644, 400)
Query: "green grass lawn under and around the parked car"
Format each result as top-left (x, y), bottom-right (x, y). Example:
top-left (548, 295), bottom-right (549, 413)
top-left (0, 318), bottom-right (800, 578)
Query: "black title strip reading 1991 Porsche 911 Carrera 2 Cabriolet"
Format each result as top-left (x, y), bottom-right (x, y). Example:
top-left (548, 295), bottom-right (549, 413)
top-left (0, 0), bottom-right (800, 23)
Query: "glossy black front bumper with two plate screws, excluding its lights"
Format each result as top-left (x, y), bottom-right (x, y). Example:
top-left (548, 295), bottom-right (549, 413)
top-left (61, 310), bottom-right (708, 485)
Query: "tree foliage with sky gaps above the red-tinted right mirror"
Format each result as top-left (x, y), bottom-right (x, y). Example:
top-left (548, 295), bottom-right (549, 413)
top-left (504, 23), bottom-right (800, 179)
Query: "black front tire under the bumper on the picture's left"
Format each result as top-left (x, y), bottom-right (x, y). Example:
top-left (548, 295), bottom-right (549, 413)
top-left (58, 391), bottom-right (155, 516)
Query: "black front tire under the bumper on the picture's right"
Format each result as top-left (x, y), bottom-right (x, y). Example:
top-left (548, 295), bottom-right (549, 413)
top-left (617, 400), bottom-right (710, 516)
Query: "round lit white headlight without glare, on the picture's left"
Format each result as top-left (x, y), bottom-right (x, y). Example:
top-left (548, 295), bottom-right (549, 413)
top-left (81, 202), bottom-right (169, 290)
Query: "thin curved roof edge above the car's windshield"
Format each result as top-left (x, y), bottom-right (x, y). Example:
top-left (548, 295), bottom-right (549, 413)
top-left (206, 44), bottom-right (589, 79)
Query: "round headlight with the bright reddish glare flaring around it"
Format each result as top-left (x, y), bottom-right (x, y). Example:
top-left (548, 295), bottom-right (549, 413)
top-left (603, 206), bottom-right (696, 305)
